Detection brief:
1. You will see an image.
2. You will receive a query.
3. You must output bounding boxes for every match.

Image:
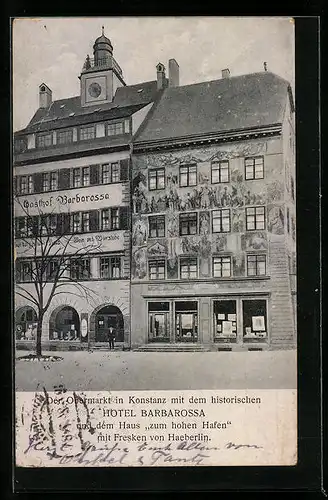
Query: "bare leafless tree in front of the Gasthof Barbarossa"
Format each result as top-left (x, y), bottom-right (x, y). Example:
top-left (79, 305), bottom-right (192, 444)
top-left (15, 197), bottom-right (100, 356)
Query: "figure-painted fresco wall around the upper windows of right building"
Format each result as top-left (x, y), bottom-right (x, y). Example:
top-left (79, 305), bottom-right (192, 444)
top-left (132, 139), bottom-right (286, 279)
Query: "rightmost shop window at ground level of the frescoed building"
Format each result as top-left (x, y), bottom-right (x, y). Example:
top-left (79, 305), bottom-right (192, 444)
top-left (242, 300), bottom-right (268, 342)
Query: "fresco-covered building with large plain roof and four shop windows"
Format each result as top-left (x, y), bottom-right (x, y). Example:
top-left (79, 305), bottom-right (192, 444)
top-left (131, 71), bottom-right (296, 350)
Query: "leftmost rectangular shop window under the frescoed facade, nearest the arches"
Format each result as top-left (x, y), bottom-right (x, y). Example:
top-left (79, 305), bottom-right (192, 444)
top-left (148, 302), bottom-right (170, 342)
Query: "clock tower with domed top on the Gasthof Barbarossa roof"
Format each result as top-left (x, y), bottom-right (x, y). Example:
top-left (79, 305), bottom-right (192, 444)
top-left (79, 27), bottom-right (125, 106)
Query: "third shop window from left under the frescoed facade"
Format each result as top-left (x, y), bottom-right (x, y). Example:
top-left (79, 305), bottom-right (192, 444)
top-left (213, 300), bottom-right (237, 342)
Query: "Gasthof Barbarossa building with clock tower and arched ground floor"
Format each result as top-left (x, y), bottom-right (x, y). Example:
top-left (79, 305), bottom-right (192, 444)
top-left (14, 30), bottom-right (165, 349)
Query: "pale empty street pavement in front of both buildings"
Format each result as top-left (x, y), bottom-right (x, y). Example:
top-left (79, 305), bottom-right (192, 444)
top-left (15, 350), bottom-right (297, 391)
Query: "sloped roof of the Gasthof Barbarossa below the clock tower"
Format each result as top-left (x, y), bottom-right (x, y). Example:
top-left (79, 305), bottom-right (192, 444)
top-left (18, 80), bottom-right (158, 134)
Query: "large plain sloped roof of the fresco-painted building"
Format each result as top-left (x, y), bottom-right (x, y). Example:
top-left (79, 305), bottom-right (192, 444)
top-left (134, 72), bottom-right (291, 144)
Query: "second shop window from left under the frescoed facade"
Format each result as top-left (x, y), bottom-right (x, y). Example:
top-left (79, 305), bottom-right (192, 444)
top-left (175, 301), bottom-right (198, 342)
